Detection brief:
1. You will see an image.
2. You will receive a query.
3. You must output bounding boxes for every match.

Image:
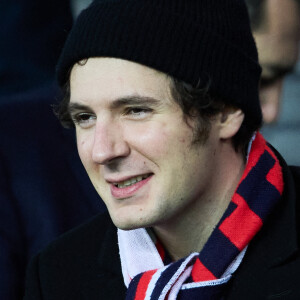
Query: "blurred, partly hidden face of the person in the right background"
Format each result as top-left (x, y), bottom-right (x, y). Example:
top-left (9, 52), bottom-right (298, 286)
top-left (253, 0), bottom-right (300, 123)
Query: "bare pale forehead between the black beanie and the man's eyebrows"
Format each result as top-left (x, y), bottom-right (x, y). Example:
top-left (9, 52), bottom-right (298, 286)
top-left (70, 58), bottom-right (170, 102)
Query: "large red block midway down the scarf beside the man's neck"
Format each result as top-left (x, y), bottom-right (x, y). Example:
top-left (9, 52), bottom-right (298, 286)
top-left (219, 194), bottom-right (263, 251)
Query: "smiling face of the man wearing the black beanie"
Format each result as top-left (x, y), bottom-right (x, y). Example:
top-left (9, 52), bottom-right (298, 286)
top-left (70, 58), bottom-right (218, 229)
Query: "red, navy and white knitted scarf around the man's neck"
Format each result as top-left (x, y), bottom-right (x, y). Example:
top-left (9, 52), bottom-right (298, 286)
top-left (118, 133), bottom-right (283, 300)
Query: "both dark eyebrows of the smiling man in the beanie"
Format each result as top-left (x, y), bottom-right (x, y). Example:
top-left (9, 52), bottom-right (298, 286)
top-left (68, 95), bottom-right (161, 114)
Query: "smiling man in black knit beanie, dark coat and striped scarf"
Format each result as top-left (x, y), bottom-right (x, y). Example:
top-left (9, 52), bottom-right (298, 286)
top-left (25, 0), bottom-right (300, 299)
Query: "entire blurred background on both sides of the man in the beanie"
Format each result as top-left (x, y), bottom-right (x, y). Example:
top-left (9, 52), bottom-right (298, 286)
top-left (0, 0), bottom-right (300, 300)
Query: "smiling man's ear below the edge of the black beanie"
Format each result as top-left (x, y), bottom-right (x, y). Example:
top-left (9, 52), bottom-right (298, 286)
top-left (219, 107), bottom-right (245, 139)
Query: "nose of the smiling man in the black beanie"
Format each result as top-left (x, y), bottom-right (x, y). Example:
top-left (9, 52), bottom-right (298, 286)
top-left (92, 122), bottom-right (130, 165)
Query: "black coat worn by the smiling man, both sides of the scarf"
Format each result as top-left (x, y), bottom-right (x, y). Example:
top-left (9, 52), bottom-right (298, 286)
top-left (25, 154), bottom-right (300, 300)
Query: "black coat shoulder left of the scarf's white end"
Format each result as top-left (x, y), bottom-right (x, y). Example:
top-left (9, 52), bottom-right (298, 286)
top-left (25, 213), bottom-right (124, 299)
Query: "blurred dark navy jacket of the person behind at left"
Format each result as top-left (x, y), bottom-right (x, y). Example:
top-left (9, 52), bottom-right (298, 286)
top-left (0, 86), bottom-right (106, 300)
